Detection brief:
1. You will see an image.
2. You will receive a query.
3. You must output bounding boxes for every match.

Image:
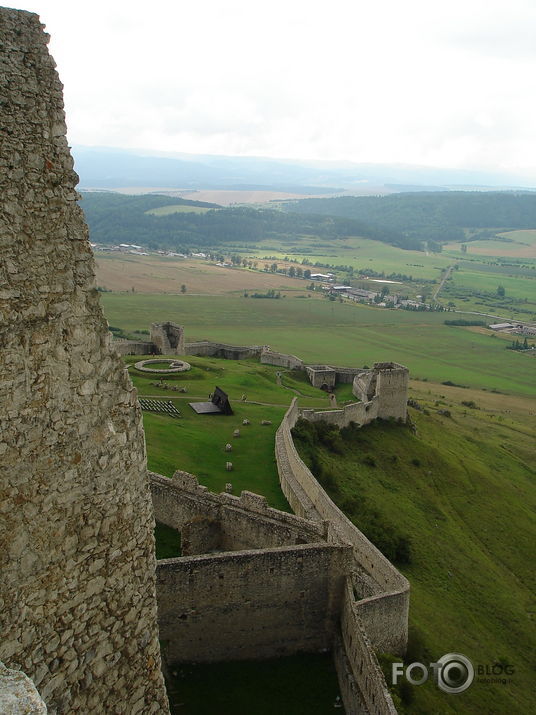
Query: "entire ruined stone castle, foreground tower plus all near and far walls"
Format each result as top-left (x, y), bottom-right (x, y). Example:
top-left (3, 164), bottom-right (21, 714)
top-left (0, 9), bottom-right (409, 715)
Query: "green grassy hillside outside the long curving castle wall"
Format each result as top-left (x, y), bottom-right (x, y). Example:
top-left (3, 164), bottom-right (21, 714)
top-left (294, 386), bottom-right (535, 715)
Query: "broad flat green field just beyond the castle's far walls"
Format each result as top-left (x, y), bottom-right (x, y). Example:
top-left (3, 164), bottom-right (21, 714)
top-left (102, 293), bottom-right (536, 394)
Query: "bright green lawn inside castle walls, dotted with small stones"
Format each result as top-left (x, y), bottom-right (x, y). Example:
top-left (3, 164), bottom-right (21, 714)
top-left (126, 357), bottom-right (328, 510)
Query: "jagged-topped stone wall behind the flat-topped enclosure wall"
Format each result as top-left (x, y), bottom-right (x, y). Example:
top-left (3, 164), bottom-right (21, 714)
top-left (150, 472), bottom-right (327, 556)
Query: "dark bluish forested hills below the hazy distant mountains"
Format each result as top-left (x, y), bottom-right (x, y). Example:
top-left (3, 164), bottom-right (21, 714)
top-left (78, 192), bottom-right (536, 251)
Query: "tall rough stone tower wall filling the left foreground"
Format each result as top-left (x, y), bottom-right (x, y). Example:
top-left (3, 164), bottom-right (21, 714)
top-left (0, 8), bottom-right (168, 715)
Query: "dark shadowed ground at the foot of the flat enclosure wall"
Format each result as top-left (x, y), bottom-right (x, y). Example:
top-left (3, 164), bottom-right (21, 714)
top-left (168, 653), bottom-right (344, 715)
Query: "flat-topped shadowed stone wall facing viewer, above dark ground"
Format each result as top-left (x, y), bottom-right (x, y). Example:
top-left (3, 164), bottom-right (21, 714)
top-left (157, 543), bottom-right (350, 662)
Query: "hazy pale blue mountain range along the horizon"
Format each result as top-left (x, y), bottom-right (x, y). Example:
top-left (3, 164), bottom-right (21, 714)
top-left (73, 146), bottom-right (536, 195)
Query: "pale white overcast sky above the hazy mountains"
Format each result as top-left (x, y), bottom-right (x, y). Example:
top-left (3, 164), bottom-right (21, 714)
top-left (11, 0), bottom-right (536, 178)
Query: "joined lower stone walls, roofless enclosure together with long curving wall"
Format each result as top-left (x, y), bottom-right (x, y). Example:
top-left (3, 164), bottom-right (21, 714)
top-left (147, 436), bottom-right (409, 715)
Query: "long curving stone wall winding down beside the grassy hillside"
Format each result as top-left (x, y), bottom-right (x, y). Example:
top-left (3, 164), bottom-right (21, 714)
top-left (275, 399), bottom-right (409, 714)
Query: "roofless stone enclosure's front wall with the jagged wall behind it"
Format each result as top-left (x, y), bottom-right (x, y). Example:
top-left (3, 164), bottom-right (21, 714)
top-left (151, 472), bottom-right (351, 662)
